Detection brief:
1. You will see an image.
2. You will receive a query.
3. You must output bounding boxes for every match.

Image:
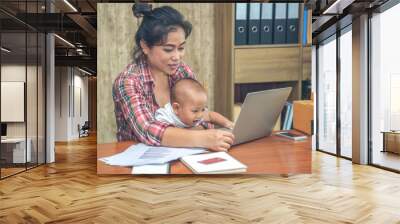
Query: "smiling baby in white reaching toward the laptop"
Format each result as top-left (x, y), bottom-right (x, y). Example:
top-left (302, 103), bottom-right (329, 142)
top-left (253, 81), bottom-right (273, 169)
top-left (155, 78), bottom-right (233, 129)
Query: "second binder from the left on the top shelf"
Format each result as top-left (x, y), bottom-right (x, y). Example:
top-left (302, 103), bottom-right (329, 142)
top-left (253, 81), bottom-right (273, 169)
top-left (248, 3), bottom-right (261, 44)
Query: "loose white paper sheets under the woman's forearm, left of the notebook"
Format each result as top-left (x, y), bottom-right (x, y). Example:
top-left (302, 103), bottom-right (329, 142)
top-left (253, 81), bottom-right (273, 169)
top-left (99, 143), bottom-right (207, 166)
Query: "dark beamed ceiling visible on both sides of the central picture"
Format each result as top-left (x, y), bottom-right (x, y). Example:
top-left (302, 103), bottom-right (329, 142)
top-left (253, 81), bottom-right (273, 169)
top-left (0, 0), bottom-right (396, 74)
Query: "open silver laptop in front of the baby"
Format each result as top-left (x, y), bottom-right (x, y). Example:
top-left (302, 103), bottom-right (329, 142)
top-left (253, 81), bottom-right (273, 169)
top-left (221, 87), bottom-right (292, 145)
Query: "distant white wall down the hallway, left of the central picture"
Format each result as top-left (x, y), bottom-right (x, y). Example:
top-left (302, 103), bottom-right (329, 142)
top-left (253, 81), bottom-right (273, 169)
top-left (55, 67), bottom-right (88, 141)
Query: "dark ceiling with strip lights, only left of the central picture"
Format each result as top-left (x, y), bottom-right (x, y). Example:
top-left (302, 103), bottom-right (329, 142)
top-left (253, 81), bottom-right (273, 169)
top-left (0, 0), bottom-right (101, 75)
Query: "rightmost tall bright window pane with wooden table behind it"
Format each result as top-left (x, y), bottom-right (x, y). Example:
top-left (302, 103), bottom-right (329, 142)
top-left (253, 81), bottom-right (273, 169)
top-left (370, 4), bottom-right (400, 170)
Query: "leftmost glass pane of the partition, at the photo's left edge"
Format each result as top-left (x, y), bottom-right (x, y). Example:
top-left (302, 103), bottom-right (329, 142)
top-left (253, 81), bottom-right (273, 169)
top-left (0, 29), bottom-right (30, 177)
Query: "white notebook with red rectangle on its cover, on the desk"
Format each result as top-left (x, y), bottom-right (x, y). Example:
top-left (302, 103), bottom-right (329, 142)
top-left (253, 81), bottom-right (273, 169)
top-left (181, 152), bottom-right (247, 174)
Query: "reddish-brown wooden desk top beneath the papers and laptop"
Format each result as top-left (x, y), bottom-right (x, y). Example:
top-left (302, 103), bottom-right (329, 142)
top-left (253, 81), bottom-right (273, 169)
top-left (97, 135), bottom-right (311, 174)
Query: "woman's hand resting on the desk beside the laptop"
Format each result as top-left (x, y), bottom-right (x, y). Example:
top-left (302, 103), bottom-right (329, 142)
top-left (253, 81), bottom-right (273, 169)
top-left (203, 129), bottom-right (235, 152)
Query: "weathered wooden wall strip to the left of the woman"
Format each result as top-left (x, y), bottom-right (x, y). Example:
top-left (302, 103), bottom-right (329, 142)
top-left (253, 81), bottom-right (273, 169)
top-left (97, 4), bottom-right (137, 143)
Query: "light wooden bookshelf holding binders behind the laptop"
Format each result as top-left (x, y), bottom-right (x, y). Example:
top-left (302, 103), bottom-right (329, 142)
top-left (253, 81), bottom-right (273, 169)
top-left (214, 3), bottom-right (311, 119)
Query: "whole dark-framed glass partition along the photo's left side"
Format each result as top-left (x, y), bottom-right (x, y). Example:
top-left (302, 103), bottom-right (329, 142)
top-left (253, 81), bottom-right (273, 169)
top-left (0, 1), bottom-right (46, 178)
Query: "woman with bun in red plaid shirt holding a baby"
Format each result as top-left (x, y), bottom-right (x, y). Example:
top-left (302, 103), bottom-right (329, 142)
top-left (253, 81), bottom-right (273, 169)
top-left (113, 3), bottom-right (234, 151)
